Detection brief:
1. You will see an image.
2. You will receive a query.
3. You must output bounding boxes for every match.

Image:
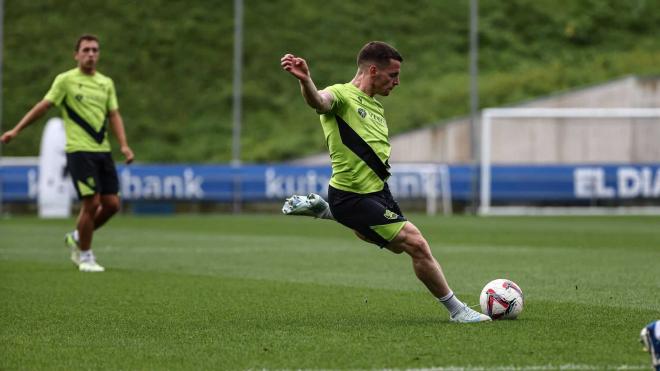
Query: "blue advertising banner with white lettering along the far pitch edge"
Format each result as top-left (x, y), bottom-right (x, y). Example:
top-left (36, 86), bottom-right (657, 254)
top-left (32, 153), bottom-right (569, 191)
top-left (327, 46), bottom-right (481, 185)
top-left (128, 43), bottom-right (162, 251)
top-left (0, 164), bottom-right (660, 202)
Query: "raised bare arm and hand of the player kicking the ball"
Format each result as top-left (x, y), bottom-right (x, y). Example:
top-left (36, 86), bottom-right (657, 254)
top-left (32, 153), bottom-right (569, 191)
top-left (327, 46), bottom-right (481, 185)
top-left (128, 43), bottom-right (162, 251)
top-left (280, 54), bottom-right (334, 113)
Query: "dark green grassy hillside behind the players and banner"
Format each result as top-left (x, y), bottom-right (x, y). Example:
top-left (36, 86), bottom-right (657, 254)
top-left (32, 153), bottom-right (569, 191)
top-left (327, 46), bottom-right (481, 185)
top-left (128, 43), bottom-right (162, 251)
top-left (2, 0), bottom-right (660, 162)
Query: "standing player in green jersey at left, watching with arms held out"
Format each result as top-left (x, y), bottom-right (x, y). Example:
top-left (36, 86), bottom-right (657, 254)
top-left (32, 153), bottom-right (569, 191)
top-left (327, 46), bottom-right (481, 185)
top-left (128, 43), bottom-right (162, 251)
top-left (0, 35), bottom-right (133, 272)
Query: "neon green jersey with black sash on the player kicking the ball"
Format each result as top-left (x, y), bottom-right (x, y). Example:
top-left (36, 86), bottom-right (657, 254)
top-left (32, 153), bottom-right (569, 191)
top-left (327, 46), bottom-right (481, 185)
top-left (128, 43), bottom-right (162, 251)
top-left (321, 83), bottom-right (390, 194)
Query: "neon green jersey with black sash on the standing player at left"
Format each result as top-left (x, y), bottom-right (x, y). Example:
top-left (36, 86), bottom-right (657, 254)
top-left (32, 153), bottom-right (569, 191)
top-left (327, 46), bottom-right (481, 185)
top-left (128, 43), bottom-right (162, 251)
top-left (44, 68), bottom-right (119, 153)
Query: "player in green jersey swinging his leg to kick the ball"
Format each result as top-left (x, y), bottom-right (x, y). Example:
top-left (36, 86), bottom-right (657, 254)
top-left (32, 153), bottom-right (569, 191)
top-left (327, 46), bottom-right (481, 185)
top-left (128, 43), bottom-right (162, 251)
top-left (281, 41), bottom-right (491, 323)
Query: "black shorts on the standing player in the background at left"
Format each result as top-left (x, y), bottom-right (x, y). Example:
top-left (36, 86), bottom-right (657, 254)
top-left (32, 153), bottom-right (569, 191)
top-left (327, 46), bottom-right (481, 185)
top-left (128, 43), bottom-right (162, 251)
top-left (66, 152), bottom-right (119, 199)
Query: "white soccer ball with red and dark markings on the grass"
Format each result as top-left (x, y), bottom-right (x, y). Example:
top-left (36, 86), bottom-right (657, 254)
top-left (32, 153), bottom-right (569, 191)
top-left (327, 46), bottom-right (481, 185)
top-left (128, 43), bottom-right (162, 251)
top-left (479, 278), bottom-right (524, 320)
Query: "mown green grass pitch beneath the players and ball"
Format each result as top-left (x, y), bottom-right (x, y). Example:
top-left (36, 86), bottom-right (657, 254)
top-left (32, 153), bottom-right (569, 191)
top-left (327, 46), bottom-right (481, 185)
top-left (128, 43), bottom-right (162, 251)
top-left (0, 215), bottom-right (660, 370)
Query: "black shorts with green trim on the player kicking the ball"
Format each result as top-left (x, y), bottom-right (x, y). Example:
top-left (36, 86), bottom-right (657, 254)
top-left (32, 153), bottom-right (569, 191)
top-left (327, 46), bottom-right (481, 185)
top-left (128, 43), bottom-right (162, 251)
top-left (328, 183), bottom-right (407, 247)
